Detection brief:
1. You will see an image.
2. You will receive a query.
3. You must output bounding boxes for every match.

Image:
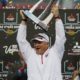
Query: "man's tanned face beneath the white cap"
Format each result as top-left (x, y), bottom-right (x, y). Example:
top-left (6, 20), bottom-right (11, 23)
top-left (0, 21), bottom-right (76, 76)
top-left (33, 40), bottom-right (48, 55)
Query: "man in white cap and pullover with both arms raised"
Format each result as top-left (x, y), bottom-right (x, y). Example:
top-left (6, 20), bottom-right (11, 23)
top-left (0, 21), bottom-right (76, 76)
top-left (17, 5), bottom-right (66, 80)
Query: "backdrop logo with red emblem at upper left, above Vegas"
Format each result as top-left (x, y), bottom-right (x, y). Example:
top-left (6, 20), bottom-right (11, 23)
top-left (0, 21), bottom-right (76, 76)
top-left (0, 10), bottom-right (19, 35)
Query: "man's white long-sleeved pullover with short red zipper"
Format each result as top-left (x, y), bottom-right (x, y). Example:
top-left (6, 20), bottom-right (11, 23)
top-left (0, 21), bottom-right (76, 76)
top-left (17, 19), bottom-right (66, 80)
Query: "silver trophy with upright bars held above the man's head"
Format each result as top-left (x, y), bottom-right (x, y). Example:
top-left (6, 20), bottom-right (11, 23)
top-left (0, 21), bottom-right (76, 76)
top-left (24, 0), bottom-right (60, 31)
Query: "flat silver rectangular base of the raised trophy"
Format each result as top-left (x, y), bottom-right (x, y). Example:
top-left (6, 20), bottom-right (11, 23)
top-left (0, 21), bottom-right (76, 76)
top-left (24, 10), bottom-right (48, 31)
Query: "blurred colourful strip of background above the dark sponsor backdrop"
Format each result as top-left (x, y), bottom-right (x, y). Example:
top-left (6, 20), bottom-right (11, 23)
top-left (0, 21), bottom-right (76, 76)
top-left (0, 0), bottom-right (80, 9)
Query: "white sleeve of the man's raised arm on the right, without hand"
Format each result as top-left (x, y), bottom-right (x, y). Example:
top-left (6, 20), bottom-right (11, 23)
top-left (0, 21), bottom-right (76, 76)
top-left (53, 19), bottom-right (66, 59)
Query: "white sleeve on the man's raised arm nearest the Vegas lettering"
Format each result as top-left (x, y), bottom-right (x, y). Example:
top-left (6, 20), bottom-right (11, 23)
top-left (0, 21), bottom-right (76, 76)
top-left (17, 24), bottom-right (32, 60)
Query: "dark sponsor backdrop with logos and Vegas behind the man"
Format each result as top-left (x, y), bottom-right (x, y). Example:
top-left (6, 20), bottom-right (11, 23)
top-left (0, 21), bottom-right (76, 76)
top-left (0, 9), bottom-right (80, 80)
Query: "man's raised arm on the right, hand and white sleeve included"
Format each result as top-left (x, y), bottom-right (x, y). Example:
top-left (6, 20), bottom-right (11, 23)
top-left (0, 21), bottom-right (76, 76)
top-left (52, 5), bottom-right (66, 59)
